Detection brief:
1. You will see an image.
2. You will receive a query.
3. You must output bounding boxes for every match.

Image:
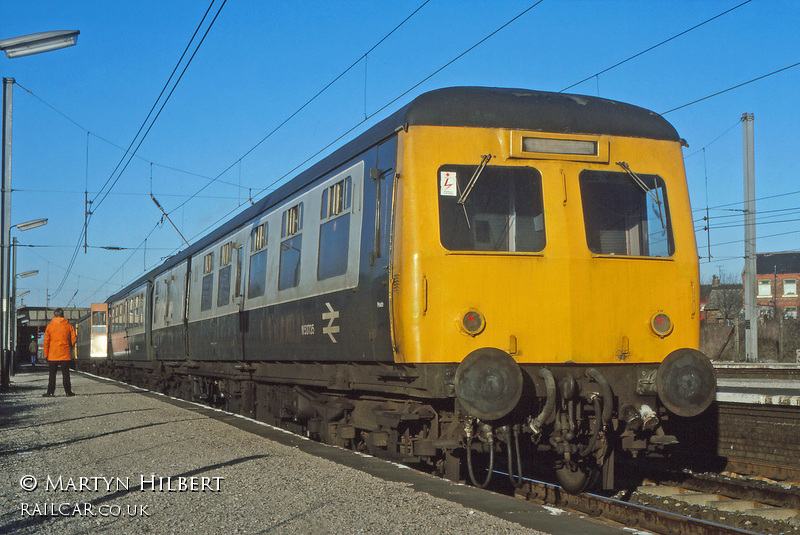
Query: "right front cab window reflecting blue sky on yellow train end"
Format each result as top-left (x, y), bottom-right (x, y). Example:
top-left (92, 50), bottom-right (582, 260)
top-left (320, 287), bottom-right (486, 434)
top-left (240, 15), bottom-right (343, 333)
top-left (580, 171), bottom-right (675, 257)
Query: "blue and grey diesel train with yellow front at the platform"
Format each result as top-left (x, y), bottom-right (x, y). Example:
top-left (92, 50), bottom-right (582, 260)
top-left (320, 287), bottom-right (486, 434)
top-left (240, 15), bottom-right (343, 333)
top-left (78, 87), bottom-right (716, 492)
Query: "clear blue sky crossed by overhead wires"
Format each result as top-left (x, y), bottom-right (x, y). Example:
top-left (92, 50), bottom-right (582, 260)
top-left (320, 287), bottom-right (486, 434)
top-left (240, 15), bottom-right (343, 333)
top-left (0, 0), bottom-right (800, 306)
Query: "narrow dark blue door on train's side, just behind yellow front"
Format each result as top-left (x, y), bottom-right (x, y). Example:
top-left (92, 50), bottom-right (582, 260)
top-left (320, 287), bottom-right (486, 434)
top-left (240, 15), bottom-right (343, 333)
top-left (365, 136), bottom-right (397, 358)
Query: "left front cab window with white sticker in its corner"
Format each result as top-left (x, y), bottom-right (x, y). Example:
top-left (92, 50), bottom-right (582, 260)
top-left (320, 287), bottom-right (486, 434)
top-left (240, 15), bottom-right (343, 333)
top-left (437, 165), bottom-right (545, 253)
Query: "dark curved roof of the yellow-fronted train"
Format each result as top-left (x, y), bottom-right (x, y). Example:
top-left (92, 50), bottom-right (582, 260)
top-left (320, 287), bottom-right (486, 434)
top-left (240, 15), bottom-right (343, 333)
top-left (107, 87), bottom-right (681, 303)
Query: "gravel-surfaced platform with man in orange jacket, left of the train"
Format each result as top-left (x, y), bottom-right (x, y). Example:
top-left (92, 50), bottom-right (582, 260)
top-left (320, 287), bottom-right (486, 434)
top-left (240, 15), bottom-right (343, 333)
top-left (0, 372), bottom-right (624, 535)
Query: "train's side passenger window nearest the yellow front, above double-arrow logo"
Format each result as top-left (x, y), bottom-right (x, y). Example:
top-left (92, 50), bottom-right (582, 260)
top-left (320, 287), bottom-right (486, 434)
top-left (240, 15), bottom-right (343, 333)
top-left (317, 177), bottom-right (353, 280)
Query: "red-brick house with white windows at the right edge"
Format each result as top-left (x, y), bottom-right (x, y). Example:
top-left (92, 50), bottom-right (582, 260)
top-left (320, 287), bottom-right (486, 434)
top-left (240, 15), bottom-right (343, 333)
top-left (756, 251), bottom-right (800, 319)
